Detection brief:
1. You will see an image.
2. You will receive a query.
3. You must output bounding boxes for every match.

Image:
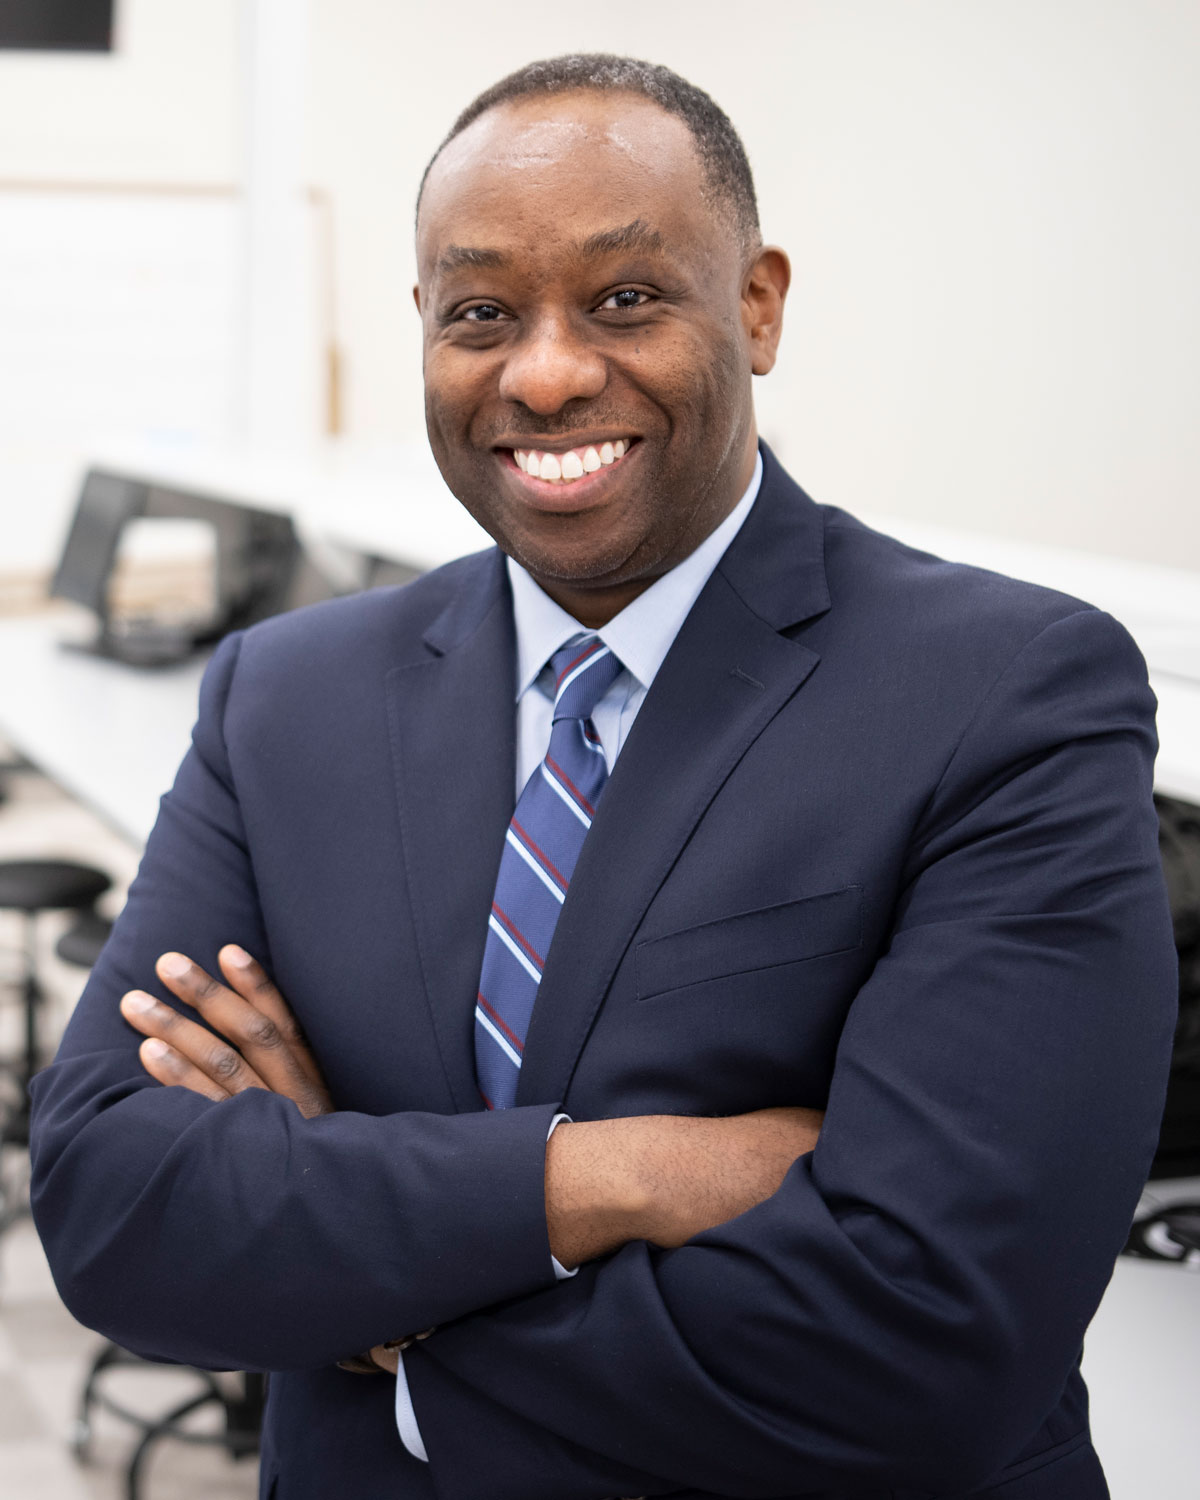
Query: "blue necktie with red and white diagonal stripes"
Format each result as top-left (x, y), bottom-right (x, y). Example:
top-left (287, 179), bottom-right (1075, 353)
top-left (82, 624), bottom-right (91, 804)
top-left (476, 636), bottom-right (621, 1110)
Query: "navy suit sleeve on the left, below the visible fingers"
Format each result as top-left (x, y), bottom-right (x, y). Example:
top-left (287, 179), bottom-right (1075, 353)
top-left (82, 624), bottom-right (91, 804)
top-left (33, 638), bottom-right (554, 1370)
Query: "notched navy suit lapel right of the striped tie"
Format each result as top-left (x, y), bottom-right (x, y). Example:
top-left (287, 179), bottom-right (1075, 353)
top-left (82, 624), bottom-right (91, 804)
top-left (516, 449), bottom-right (830, 1104)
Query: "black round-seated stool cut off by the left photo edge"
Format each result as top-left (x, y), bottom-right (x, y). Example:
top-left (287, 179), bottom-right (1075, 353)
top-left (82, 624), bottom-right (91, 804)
top-left (0, 860), bottom-right (113, 1233)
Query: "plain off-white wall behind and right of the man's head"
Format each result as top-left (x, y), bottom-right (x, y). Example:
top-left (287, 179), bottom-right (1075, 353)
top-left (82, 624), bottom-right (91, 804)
top-left (311, 0), bottom-right (1200, 567)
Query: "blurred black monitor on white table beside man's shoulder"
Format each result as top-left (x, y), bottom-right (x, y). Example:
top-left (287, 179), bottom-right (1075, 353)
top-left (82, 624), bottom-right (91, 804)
top-left (50, 470), bottom-right (304, 666)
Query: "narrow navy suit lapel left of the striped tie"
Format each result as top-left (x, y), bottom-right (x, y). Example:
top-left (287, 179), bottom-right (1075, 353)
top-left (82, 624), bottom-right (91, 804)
top-left (387, 552), bottom-right (516, 1112)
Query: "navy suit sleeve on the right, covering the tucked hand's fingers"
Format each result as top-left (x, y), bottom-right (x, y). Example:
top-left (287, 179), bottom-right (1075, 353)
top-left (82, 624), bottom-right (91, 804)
top-left (407, 611), bottom-right (1176, 1500)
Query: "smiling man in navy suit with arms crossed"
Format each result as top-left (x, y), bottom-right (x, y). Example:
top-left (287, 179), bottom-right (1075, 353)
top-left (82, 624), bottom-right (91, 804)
top-left (35, 57), bottom-right (1175, 1500)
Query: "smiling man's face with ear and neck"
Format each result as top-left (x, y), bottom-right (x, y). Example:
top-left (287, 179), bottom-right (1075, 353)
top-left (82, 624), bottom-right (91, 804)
top-left (417, 92), bottom-right (786, 624)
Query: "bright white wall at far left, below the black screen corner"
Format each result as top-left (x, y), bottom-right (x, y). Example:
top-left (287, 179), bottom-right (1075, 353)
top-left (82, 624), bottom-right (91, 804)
top-left (0, 0), bottom-right (242, 575)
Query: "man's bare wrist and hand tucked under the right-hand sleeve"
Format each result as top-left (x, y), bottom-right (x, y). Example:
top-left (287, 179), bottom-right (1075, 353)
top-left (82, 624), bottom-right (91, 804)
top-left (546, 1109), bottom-right (825, 1266)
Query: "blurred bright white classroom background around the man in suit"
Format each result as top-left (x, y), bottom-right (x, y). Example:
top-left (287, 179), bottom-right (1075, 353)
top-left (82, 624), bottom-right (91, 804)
top-left (0, 0), bottom-right (1200, 1500)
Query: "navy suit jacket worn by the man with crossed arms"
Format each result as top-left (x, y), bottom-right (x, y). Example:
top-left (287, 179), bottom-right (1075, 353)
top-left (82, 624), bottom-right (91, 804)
top-left (35, 452), bottom-right (1176, 1500)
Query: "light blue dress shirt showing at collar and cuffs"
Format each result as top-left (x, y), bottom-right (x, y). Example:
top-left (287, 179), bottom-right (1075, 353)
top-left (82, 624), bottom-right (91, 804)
top-left (396, 455), bottom-right (762, 1463)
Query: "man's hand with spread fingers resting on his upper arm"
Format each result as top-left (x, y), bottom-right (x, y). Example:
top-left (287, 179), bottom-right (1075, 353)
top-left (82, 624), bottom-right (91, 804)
top-left (122, 944), bottom-right (333, 1119)
